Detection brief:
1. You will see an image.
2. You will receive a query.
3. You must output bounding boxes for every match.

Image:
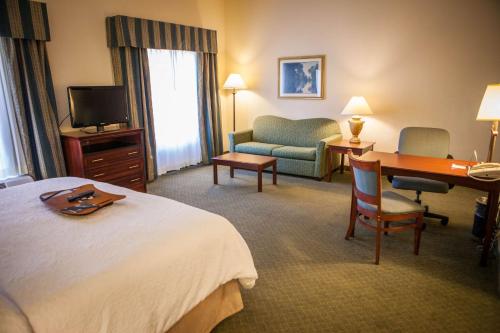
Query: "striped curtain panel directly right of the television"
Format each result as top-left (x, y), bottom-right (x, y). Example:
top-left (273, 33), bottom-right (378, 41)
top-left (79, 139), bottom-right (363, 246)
top-left (111, 47), bottom-right (157, 181)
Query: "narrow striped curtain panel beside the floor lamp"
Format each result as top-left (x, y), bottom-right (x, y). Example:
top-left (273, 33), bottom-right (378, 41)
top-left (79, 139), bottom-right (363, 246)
top-left (198, 53), bottom-right (223, 164)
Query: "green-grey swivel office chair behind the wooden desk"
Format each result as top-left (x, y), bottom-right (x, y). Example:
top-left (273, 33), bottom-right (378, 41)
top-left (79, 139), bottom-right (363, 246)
top-left (387, 127), bottom-right (453, 225)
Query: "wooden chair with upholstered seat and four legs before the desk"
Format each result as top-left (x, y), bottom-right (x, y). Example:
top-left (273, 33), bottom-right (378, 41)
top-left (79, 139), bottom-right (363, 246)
top-left (345, 151), bottom-right (424, 265)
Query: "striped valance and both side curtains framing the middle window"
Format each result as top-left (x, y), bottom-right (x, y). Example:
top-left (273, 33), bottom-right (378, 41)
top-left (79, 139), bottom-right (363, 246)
top-left (106, 15), bottom-right (222, 172)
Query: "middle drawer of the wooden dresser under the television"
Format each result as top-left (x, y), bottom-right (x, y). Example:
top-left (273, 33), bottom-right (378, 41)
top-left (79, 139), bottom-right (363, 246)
top-left (85, 158), bottom-right (144, 182)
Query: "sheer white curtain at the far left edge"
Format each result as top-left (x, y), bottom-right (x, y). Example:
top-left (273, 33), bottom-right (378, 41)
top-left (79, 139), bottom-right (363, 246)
top-left (0, 50), bottom-right (27, 179)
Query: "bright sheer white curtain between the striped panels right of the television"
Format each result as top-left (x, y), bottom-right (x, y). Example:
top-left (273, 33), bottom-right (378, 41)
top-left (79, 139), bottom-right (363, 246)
top-left (148, 49), bottom-right (201, 175)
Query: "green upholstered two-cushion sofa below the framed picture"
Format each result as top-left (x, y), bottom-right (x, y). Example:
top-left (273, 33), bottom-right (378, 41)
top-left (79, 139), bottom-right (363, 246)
top-left (229, 116), bottom-right (342, 178)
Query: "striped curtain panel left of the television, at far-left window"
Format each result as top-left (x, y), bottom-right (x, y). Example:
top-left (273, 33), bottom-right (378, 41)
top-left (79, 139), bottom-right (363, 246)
top-left (0, 37), bottom-right (66, 179)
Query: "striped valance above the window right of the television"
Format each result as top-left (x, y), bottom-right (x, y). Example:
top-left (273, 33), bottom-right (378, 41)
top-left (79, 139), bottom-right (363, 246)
top-left (106, 15), bottom-right (217, 53)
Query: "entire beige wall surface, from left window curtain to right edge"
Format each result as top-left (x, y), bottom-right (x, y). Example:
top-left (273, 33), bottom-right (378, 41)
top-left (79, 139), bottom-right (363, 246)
top-left (46, 0), bottom-right (500, 159)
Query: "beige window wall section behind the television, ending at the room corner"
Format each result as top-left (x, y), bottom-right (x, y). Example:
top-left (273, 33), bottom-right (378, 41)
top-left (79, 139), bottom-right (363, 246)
top-left (46, 0), bottom-right (231, 139)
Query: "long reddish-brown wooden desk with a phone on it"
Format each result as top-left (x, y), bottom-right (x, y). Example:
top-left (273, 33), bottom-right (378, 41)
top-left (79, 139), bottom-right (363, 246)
top-left (361, 151), bottom-right (500, 266)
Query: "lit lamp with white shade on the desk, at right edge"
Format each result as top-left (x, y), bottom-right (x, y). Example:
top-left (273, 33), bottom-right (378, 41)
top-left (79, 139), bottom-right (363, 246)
top-left (476, 84), bottom-right (500, 162)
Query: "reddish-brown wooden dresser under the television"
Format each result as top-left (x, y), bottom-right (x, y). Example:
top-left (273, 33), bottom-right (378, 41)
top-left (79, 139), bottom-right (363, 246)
top-left (61, 128), bottom-right (146, 192)
